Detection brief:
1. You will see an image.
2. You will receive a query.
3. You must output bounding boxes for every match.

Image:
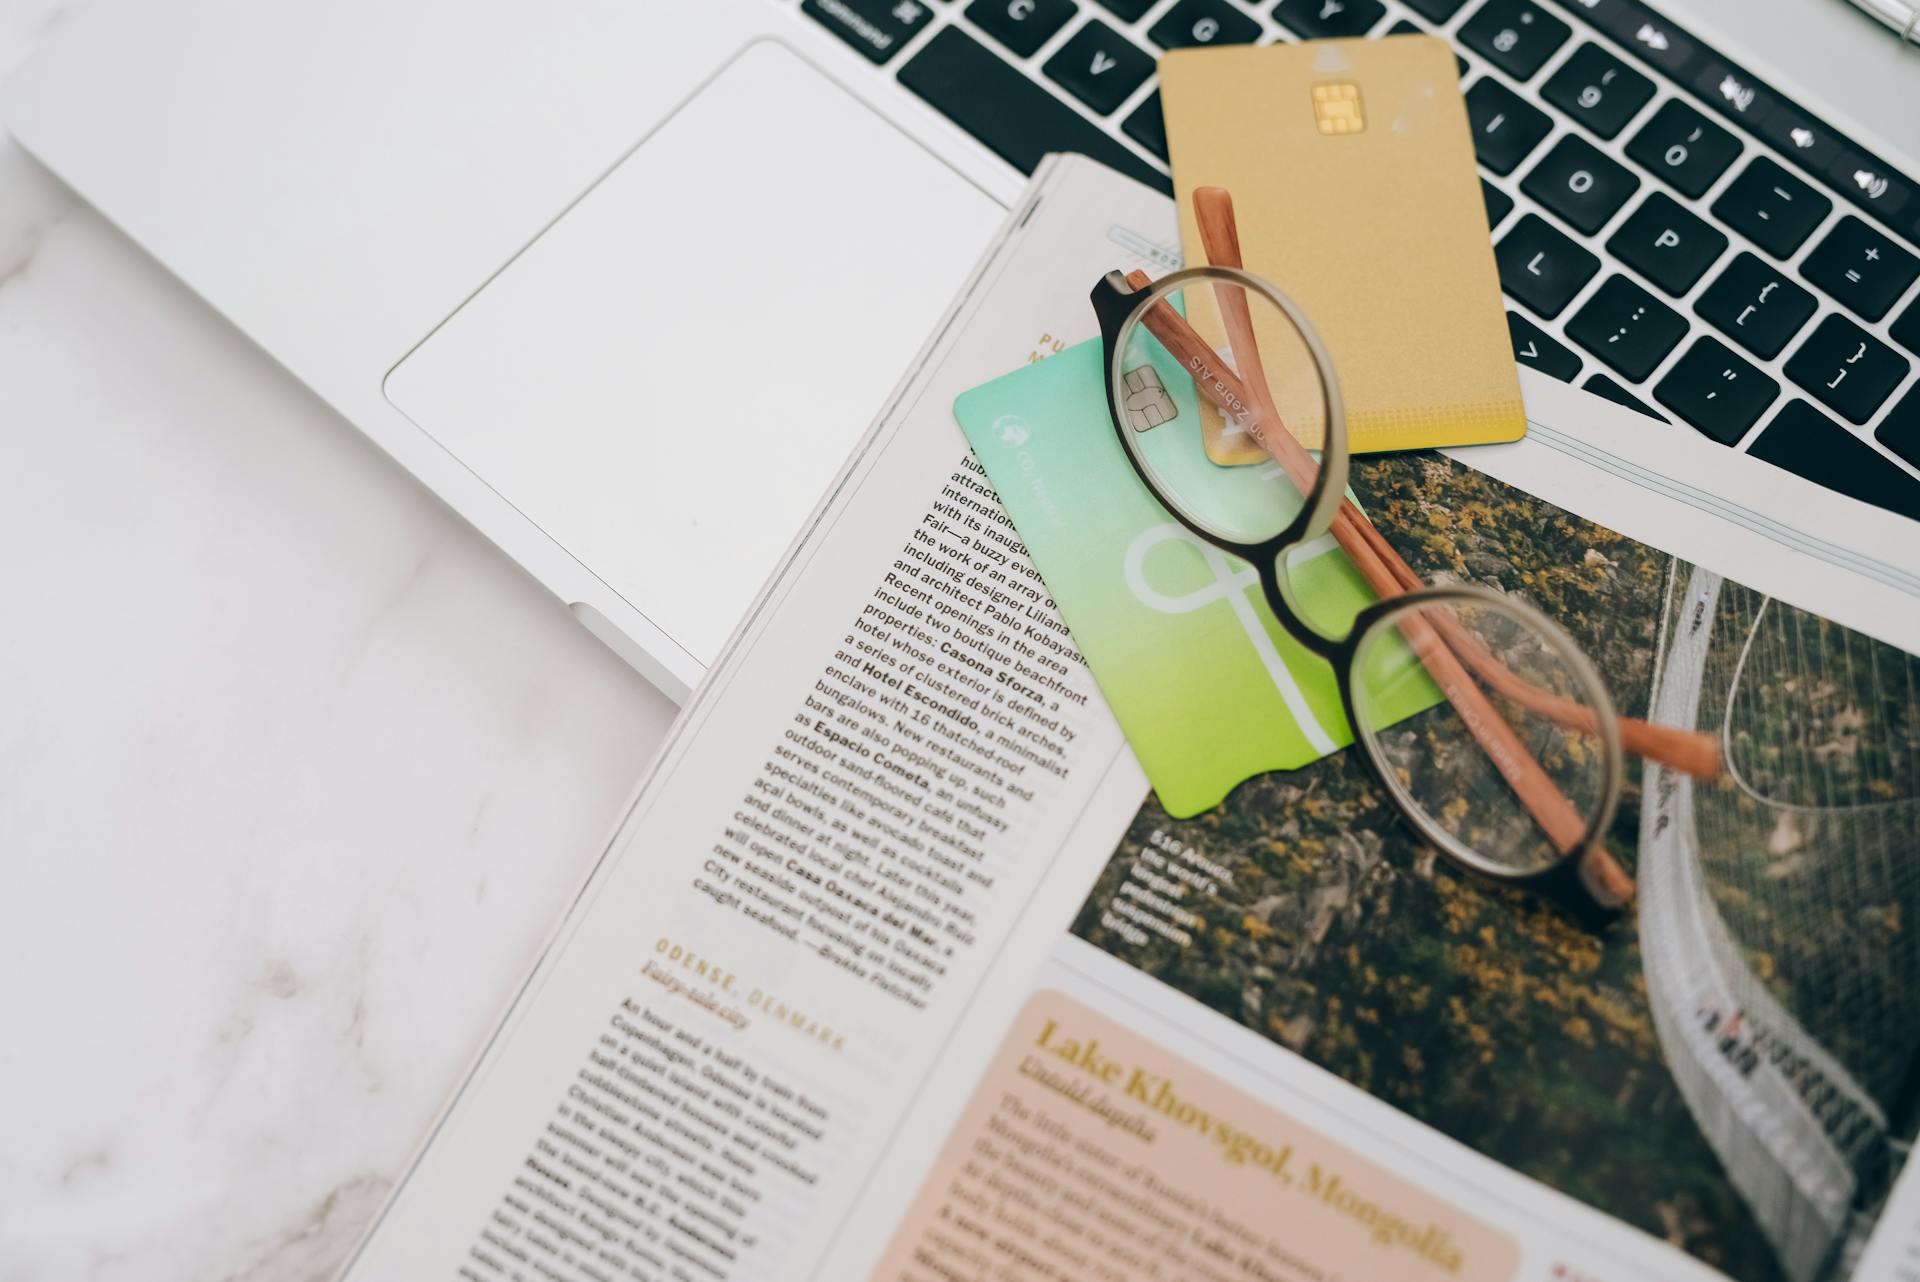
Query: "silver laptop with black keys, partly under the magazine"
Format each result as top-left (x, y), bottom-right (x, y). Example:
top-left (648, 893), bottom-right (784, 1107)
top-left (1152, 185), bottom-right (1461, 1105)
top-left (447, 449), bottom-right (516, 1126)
top-left (0, 0), bottom-right (1920, 697)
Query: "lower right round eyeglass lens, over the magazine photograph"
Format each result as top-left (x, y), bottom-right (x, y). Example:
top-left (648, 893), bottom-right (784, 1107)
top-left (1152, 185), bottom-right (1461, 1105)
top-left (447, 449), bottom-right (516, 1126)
top-left (1352, 595), bottom-right (1620, 877)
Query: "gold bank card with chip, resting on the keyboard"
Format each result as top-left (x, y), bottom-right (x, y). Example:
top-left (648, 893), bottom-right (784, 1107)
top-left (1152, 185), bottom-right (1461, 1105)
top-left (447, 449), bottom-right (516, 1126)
top-left (1160, 36), bottom-right (1526, 463)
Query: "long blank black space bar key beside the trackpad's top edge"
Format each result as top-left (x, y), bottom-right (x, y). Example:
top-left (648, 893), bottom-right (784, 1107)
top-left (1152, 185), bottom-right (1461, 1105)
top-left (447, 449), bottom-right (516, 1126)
top-left (900, 27), bottom-right (1173, 194)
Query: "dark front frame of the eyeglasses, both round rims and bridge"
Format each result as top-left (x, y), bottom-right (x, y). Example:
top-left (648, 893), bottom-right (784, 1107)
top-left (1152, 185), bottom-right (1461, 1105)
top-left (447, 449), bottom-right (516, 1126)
top-left (1091, 265), bottom-right (1626, 925)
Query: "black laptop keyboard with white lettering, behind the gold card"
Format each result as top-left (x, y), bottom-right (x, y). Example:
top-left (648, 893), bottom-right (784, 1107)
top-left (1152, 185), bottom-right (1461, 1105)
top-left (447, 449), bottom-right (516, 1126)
top-left (801, 0), bottom-right (1920, 520)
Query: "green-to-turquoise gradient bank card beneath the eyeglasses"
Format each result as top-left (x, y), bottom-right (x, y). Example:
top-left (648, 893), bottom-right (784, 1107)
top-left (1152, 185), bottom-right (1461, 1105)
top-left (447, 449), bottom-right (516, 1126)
top-left (954, 330), bottom-right (1436, 818)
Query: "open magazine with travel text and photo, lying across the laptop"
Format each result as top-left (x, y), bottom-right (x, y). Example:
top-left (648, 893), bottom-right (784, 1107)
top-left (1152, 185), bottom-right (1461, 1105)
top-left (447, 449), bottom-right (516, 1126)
top-left (346, 157), bottom-right (1920, 1282)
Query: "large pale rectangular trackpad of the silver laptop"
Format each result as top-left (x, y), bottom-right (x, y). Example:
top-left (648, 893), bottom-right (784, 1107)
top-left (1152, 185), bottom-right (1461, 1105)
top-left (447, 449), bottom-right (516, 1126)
top-left (386, 42), bottom-right (1002, 664)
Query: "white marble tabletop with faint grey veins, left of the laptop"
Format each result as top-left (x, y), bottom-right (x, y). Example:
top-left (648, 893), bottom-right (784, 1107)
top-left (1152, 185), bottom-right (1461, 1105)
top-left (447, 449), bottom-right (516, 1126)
top-left (0, 0), bottom-right (674, 1282)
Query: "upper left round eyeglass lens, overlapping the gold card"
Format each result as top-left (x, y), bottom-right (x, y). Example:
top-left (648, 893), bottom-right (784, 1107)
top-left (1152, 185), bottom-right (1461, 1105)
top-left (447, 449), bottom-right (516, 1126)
top-left (1108, 269), bottom-right (1329, 543)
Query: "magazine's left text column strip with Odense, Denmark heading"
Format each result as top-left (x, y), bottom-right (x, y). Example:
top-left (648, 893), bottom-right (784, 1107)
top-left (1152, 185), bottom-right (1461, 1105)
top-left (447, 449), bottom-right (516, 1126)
top-left (346, 159), bottom-right (1173, 1282)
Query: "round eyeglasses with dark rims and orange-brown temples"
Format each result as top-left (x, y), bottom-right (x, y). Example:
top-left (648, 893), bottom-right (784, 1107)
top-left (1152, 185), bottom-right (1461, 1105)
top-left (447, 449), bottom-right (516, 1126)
top-left (1092, 188), bottom-right (1720, 923)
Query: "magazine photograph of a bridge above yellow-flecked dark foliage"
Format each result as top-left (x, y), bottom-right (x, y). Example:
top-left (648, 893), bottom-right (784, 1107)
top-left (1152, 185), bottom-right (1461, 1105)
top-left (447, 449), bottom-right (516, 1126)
top-left (1073, 455), bottom-right (1920, 1282)
